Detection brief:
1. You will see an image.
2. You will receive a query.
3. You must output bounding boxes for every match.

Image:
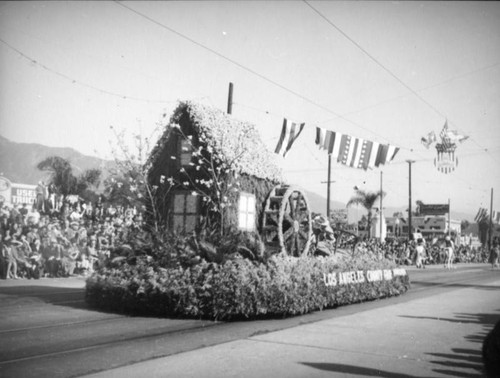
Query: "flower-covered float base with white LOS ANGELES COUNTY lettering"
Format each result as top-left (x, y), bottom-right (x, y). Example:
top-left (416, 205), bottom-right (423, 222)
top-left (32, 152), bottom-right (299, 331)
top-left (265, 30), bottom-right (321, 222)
top-left (86, 257), bottom-right (410, 320)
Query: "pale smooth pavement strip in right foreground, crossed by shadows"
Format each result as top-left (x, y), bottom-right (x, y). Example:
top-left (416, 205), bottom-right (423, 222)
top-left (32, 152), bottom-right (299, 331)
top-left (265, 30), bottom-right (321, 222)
top-left (83, 273), bottom-right (500, 378)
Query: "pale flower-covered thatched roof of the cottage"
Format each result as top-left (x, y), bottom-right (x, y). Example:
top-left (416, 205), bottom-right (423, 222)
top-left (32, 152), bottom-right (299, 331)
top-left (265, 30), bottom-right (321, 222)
top-left (150, 101), bottom-right (283, 182)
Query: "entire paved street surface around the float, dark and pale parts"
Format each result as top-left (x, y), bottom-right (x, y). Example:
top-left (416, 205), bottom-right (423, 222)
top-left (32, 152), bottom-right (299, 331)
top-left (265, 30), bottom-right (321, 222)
top-left (0, 264), bottom-right (500, 377)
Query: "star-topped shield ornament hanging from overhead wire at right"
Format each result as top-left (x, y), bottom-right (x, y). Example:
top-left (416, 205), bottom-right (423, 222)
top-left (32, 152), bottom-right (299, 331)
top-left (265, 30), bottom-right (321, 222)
top-left (421, 121), bottom-right (468, 174)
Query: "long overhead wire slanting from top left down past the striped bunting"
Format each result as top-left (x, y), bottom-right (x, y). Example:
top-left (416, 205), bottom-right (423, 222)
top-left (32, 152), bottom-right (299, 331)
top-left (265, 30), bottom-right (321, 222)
top-left (115, 0), bottom-right (411, 151)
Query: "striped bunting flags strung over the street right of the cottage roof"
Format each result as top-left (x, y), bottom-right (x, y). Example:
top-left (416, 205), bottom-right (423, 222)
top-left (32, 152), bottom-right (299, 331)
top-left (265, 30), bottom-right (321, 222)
top-left (274, 118), bottom-right (399, 170)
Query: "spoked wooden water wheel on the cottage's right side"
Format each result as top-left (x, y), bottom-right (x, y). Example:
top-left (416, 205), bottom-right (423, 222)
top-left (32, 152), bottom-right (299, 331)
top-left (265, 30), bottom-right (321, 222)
top-left (262, 185), bottom-right (312, 256)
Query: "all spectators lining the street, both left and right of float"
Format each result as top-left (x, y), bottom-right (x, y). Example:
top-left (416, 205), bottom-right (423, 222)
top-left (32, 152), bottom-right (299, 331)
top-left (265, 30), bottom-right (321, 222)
top-left (0, 199), bottom-right (499, 279)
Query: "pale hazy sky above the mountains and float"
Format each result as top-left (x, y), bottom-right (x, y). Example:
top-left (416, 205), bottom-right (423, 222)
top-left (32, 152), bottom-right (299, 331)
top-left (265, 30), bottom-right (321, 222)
top-left (0, 1), bottom-right (500, 215)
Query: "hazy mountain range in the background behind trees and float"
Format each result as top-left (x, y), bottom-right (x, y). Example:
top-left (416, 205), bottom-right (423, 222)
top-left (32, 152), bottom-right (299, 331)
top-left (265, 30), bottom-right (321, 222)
top-left (0, 135), bottom-right (473, 221)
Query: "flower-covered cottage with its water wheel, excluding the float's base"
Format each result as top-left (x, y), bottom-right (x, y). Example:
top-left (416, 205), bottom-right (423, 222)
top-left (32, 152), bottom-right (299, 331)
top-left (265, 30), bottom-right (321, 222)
top-left (149, 99), bottom-right (312, 256)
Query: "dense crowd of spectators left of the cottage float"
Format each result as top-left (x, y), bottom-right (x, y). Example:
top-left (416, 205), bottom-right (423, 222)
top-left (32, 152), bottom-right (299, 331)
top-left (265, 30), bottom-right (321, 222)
top-left (0, 200), bottom-right (143, 279)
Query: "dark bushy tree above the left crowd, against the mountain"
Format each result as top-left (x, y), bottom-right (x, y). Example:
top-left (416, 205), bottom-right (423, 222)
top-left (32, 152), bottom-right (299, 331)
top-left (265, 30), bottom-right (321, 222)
top-left (37, 156), bottom-right (101, 200)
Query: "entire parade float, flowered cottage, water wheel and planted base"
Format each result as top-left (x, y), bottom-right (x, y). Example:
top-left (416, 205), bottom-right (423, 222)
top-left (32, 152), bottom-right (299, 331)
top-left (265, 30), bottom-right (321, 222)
top-left (86, 102), bottom-right (409, 319)
